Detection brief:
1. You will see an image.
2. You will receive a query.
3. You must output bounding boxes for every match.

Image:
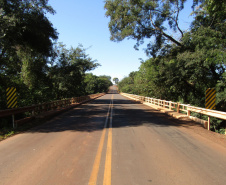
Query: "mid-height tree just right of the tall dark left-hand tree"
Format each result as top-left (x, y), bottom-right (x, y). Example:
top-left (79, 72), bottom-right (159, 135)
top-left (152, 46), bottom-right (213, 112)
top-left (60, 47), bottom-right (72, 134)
top-left (48, 44), bottom-right (99, 99)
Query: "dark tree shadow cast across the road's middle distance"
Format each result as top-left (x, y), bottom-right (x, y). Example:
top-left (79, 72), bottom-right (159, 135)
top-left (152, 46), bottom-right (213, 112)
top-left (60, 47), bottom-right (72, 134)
top-left (26, 96), bottom-right (200, 133)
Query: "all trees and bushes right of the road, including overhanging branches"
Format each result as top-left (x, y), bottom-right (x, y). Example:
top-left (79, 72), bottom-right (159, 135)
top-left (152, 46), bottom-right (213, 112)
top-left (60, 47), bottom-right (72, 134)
top-left (105, 0), bottom-right (226, 130)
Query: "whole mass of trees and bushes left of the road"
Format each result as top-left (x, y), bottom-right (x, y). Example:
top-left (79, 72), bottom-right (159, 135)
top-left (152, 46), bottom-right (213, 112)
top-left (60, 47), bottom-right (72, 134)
top-left (0, 0), bottom-right (112, 129)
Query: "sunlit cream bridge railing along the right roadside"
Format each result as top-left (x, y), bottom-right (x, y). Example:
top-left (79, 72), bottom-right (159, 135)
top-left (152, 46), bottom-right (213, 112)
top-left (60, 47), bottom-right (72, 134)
top-left (121, 93), bottom-right (226, 130)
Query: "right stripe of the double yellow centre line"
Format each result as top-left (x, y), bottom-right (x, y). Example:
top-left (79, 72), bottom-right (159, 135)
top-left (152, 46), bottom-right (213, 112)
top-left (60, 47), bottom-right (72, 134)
top-left (103, 95), bottom-right (113, 185)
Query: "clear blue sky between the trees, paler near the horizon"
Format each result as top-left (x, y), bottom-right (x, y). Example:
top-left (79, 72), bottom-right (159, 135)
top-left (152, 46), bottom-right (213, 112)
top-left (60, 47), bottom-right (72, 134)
top-left (47, 0), bottom-right (191, 80)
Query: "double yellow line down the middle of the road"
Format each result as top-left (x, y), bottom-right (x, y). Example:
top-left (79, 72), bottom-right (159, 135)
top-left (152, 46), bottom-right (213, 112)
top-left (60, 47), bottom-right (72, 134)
top-left (89, 95), bottom-right (113, 185)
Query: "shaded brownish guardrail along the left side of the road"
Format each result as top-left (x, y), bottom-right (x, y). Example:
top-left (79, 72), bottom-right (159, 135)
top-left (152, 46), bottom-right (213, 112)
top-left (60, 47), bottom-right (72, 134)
top-left (0, 93), bottom-right (105, 127)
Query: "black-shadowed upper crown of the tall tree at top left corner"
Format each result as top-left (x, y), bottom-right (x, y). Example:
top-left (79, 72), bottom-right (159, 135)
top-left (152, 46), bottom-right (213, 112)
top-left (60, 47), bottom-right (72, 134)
top-left (0, 0), bottom-right (58, 61)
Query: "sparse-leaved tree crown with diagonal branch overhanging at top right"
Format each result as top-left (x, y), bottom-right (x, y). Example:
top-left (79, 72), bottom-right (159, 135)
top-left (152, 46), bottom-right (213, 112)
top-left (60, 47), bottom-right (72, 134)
top-left (105, 0), bottom-right (196, 57)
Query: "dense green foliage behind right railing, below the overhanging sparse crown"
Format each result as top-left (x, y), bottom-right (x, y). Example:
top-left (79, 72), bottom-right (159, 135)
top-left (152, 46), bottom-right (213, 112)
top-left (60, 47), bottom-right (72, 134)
top-left (117, 0), bottom-right (226, 133)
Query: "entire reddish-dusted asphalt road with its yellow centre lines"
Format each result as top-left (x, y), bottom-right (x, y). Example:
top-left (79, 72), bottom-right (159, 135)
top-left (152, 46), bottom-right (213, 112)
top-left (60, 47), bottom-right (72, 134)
top-left (0, 86), bottom-right (226, 185)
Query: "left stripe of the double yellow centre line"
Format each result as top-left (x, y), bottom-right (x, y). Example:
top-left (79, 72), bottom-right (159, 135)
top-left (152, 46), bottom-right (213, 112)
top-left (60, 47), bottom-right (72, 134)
top-left (89, 95), bottom-right (113, 185)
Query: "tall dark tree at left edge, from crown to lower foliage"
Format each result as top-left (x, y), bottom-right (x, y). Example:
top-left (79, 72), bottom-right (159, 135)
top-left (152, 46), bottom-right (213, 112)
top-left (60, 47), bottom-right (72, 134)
top-left (0, 0), bottom-right (58, 107)
